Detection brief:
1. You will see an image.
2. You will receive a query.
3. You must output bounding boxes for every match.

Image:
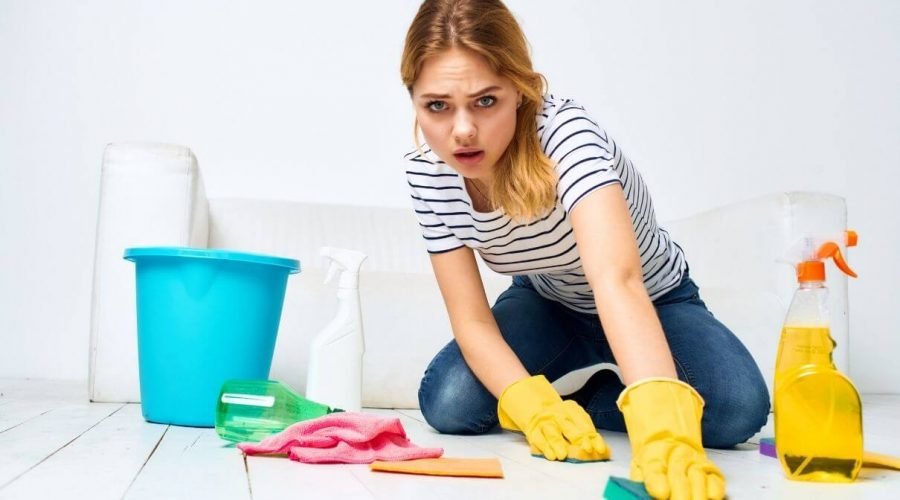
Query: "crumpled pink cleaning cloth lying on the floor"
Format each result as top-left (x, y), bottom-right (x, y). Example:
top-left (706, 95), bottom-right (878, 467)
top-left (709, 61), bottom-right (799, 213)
top-left (237, 412), bottom-right (444, 464)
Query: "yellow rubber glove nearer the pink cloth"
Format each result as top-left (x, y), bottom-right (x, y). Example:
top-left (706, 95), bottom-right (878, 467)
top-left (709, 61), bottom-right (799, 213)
top-left (497, 375), bottom-right (610, 462)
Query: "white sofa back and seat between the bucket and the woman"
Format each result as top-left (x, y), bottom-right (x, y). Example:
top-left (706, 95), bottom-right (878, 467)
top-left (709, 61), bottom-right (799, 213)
top-left (209, 199), bottom-right (511, 408)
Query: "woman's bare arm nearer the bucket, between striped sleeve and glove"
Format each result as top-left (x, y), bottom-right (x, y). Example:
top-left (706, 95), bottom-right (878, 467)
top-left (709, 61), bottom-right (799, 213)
top-left (431, 247), bottom-right (528, 398)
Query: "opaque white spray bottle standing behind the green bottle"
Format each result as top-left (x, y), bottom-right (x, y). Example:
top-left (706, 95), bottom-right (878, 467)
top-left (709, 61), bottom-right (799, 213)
top-left (306, 247), bottom-right (366, 411)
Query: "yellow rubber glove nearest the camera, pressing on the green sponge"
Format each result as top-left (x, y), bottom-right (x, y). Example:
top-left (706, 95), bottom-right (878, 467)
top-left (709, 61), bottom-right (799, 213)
top-left (617, 378), bottom-right (725, 500)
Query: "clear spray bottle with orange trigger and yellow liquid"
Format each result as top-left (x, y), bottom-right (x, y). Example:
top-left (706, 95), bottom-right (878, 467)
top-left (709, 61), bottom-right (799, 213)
top-left (774, 231), bottom-right (863, 482)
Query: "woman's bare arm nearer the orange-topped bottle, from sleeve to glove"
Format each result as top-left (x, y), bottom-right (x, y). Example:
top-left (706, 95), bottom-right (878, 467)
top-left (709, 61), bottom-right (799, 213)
top-left (570, 184), bottom-right (677, 386)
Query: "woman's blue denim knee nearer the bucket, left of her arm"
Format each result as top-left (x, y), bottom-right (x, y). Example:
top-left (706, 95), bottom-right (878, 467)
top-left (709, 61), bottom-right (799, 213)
top-left (419, 344), bottom-right (497, 434)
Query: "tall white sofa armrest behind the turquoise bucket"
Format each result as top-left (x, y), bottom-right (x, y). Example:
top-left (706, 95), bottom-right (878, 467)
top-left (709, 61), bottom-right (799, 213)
top-left (88, 143), bottom-right (208, 402)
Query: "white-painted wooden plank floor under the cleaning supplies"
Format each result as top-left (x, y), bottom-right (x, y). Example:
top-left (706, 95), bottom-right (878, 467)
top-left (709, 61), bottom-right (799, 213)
top-left (0, 380), bottom-right (900, 500)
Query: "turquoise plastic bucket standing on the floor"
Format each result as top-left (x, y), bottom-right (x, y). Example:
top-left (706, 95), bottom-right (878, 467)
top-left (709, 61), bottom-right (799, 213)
top-left (125, 247), bottom-right (300, 427)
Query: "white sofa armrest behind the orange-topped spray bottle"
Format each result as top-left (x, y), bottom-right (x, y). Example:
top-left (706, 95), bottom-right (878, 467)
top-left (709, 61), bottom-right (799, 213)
top-left (664, 192), bottom-right (849, 394)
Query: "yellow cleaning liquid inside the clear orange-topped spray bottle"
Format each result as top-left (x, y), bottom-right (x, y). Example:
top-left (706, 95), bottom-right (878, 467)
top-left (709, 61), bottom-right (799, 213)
top-left (775, 326), bottom-right (863, 482)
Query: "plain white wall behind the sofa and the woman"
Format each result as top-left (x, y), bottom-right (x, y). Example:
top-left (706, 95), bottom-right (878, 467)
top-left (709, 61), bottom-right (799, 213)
top-left (0, 0), bottom-right (900, 392)
